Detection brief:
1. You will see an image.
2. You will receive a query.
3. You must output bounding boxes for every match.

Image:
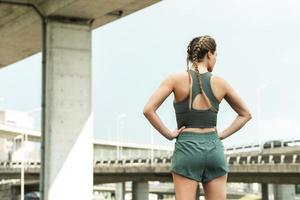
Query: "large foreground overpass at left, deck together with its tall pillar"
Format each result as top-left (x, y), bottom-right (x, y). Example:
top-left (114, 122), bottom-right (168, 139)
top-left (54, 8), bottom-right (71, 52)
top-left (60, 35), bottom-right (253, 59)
top-left (0, 0), bottom-right (162, 200)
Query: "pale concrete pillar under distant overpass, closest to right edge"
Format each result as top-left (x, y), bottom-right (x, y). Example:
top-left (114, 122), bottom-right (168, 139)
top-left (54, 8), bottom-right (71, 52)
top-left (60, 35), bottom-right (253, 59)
top-left (274, 184), bottom-right (296, 200)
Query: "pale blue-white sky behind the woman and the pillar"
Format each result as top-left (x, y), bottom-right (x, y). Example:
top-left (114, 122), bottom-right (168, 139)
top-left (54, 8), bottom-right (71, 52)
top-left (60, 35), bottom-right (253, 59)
top-left (0, 0), bottom-right (300, 146)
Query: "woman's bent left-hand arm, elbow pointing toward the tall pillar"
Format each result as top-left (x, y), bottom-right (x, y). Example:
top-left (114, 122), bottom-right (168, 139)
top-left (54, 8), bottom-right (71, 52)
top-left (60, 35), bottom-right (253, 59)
top-left (143, 75), bottom-right (185, 140)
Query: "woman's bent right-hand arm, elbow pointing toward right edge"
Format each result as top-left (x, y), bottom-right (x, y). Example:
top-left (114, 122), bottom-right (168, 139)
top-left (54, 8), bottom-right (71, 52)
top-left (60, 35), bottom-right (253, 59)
top-left (219, 79), bottom-right (252, 140)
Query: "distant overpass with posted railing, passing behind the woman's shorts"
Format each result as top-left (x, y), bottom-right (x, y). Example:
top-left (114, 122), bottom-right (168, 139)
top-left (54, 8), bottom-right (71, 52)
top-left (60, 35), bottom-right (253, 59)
top-left (0, 154), bottom-right (300, 200)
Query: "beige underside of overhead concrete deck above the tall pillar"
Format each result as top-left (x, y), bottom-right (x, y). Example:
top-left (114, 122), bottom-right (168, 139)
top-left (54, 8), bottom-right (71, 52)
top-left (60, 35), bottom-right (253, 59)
top-left (0, 0), bottom-right (160, 68)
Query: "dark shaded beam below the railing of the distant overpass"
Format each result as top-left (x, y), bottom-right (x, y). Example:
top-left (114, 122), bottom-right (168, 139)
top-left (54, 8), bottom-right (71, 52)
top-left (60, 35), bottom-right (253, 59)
top-left (0, 167), bottom-right (300, 184)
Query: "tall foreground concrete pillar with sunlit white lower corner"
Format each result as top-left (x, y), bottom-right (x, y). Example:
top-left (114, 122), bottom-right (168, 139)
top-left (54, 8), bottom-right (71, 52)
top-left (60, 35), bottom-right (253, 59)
top-left (41, 19), bottom-right (93, 200)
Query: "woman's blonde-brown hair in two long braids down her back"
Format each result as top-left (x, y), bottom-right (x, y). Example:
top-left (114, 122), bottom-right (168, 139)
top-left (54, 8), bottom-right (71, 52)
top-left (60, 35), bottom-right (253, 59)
top-left (186, 35), bottom-right (217, 112)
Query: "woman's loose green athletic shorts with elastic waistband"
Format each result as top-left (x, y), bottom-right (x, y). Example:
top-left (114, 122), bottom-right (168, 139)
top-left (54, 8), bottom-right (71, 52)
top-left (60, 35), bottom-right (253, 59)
top-left (171, 131), bottom-right (229, 183)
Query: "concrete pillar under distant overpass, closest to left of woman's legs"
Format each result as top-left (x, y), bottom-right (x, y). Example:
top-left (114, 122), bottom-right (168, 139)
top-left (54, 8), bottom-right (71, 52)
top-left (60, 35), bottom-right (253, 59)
top-left (132, 181), bottom-right (149, 200)
